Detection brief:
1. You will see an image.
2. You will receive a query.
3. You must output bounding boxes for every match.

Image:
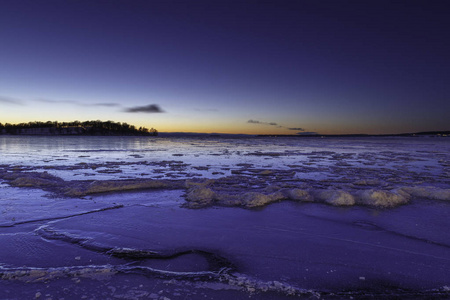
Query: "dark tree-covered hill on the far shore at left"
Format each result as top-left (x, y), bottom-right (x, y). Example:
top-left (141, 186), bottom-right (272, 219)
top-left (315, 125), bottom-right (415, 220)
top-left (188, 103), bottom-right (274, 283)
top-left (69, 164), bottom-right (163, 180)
top-left (0, 120), bottom-right (158, 136)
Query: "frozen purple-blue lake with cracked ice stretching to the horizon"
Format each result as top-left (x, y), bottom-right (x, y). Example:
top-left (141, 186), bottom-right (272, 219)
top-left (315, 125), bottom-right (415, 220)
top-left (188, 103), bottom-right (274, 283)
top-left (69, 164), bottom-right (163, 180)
top-left (0, 136), bottom-right (450, 299)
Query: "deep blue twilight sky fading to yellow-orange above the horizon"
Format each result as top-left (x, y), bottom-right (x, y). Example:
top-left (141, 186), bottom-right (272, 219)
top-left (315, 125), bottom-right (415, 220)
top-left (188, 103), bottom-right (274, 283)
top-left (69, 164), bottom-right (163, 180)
top-left (0, 0), bottom-right (450, 134)
